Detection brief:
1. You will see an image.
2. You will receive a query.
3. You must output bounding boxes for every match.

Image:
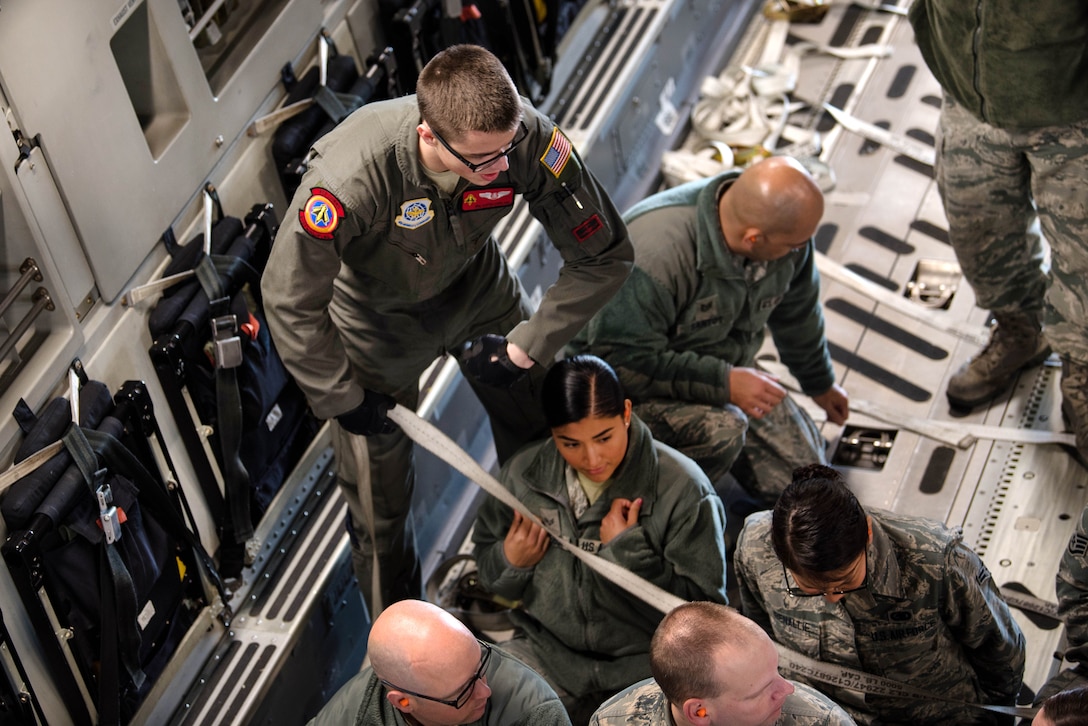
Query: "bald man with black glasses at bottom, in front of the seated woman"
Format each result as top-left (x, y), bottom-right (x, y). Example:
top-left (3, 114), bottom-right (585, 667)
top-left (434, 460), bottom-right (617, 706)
top-left (310, 600), bottom-right (570, 726)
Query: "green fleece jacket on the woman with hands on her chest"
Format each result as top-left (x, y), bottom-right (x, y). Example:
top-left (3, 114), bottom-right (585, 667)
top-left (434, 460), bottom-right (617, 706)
top-left (472, 417), bottom-right (726, 696)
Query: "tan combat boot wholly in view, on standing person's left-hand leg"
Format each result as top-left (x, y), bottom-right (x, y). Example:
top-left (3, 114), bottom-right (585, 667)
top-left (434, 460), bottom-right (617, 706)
top-left (947, 311), bottom-right (1050, 409)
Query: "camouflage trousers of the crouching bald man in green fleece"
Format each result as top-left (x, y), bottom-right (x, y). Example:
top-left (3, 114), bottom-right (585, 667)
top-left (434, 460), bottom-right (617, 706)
top-left (634, 396), bottom-right (827, 506)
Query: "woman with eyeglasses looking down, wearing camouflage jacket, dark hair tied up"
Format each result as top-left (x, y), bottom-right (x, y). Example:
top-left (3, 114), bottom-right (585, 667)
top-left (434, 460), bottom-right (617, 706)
top-left (734, 465), bottom-right (1025, 724)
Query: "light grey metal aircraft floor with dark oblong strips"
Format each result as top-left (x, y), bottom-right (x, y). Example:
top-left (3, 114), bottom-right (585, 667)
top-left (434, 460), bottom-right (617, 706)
top-left (718, 2), bottom-right (1088, 689)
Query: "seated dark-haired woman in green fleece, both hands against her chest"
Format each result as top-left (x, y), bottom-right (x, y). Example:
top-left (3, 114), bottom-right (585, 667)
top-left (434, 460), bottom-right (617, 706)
top-left (473, 356), bottom-right (726, 724)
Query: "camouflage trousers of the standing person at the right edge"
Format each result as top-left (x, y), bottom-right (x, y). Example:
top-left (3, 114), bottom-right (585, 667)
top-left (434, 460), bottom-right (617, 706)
top-left (936, 95), bottom-right (1088, 365)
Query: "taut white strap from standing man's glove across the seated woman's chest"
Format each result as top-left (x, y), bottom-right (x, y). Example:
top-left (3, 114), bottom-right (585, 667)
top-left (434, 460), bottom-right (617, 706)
top-left (390, 406), bottom-right (687, 613)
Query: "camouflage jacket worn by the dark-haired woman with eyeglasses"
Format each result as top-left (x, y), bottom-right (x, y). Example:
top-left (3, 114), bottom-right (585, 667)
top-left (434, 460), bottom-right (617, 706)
top-left (734, 509), bottom-right (1025, 724)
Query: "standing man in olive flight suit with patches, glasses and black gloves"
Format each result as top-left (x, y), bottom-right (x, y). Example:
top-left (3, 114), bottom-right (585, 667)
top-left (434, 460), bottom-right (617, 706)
top-left (261, 46), bottom-right (633, 611)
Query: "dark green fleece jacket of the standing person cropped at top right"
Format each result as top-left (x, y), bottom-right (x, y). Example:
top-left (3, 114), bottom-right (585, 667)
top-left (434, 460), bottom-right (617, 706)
top-left (911, 0), bottom-right (1088, 128)
